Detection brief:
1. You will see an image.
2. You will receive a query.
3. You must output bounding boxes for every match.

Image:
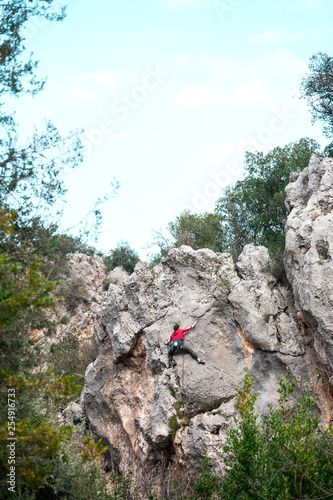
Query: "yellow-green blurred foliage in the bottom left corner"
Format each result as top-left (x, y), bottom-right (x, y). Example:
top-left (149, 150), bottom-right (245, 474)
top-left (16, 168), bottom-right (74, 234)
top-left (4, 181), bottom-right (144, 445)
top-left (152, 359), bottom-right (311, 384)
top-left (0, 368), bottom-right (78, 490)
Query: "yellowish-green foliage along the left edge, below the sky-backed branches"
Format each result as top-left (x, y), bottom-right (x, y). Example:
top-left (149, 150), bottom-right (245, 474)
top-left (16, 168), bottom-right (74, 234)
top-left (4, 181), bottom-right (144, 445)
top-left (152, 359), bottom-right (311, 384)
top-left (0, 210), bottom-right (75, 490)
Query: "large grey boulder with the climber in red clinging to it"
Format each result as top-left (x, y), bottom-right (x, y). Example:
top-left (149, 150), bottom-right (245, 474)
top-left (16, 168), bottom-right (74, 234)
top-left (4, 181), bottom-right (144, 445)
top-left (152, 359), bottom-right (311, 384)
top-left (82, 245), bottom-right (326, 473)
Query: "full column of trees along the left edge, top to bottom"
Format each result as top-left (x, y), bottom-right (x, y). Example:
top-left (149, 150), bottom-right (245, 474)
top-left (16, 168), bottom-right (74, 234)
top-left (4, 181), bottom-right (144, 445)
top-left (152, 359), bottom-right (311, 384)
top-left (0, 5), bottom-right (109, 498)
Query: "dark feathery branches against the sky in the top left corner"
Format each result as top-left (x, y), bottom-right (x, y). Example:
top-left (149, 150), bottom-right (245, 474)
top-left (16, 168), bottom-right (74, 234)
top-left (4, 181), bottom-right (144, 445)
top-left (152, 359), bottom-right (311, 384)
top-left (0, 0), bottom-right (78, 220)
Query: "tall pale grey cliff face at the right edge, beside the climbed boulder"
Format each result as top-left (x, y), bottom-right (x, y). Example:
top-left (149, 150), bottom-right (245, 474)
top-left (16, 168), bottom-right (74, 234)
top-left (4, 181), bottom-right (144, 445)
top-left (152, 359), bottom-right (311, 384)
top-left (284, 155), bottom-right (333, 371)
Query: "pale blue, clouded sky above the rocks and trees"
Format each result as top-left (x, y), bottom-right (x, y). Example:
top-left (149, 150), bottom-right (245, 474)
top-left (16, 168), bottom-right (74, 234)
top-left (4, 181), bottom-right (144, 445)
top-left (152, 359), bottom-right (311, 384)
top-left (11, 0), bottom-right (333, 258)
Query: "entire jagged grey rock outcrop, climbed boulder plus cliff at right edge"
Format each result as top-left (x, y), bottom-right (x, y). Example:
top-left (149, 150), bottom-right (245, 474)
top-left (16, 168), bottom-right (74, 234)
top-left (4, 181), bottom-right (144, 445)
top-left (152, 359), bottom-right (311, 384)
top-left (82, 152), bottom-right (333, 473)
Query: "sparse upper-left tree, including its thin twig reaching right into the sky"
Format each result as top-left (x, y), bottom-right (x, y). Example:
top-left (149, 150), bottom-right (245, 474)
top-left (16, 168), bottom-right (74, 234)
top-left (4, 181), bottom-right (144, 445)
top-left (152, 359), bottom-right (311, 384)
top-left (0, 0), bottom-right (118, 267)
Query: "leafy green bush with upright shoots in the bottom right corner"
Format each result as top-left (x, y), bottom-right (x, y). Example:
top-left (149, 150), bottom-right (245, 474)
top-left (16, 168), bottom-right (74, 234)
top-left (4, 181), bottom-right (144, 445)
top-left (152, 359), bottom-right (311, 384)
top-left (195, 372), bottom-right (333, 500)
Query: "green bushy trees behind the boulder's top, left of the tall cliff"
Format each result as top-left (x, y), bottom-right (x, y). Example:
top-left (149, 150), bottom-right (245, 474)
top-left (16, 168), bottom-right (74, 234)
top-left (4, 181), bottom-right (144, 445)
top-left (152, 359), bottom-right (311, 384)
top-left (162, 138), bottom-right (320, 264)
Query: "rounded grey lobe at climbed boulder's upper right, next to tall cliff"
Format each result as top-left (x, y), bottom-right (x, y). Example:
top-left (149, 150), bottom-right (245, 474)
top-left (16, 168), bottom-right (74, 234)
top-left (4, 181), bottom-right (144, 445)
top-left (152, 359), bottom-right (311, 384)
top-left (229, 245), bottom-right (305, 356)
